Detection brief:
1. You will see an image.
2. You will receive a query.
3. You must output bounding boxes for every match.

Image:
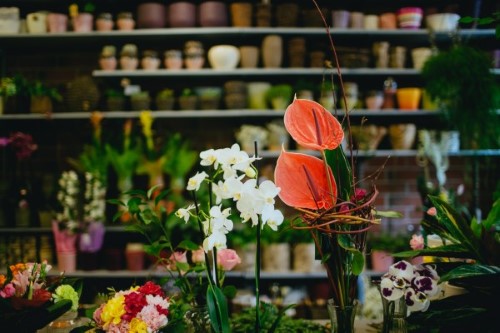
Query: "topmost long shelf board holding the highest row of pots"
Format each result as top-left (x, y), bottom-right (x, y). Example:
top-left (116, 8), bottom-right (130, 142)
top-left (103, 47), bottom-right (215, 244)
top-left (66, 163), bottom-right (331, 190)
top-left (0, 27), bottom-right (495, 48)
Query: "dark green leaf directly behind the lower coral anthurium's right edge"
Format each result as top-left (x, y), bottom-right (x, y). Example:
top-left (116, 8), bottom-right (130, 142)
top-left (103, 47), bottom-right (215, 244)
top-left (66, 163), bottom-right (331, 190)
top-left (325, 146), bottom-right (353, 200)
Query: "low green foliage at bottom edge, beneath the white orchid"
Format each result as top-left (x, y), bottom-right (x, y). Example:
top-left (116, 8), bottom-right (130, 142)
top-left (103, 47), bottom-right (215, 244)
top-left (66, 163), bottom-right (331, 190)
top-left (231, 303), bottom-right (329, 333)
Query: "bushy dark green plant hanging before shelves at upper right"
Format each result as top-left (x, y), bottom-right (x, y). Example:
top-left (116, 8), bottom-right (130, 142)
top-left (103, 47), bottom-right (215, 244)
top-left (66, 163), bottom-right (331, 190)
top-left (422, 45), bottom-right (500, 149)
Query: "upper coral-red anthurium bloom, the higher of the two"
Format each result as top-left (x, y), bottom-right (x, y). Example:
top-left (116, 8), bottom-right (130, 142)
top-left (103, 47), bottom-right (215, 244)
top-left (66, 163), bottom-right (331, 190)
top-left (284, 98), bottom-right (344, 150)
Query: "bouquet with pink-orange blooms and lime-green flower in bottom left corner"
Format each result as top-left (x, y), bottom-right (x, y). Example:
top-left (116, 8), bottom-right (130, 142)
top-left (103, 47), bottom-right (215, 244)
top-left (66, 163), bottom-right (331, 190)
top-left (0, 262), bottom-right (82, 332)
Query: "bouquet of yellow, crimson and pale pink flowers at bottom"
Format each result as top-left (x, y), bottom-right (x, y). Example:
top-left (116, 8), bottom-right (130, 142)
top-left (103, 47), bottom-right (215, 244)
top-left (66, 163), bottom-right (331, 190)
top-left (89, 281), bottom-right (170, 332)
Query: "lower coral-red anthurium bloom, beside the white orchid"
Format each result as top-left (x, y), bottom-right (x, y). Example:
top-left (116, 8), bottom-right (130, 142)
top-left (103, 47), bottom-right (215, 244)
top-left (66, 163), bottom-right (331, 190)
top-left (274, 150), bottom-right (337, 210)
